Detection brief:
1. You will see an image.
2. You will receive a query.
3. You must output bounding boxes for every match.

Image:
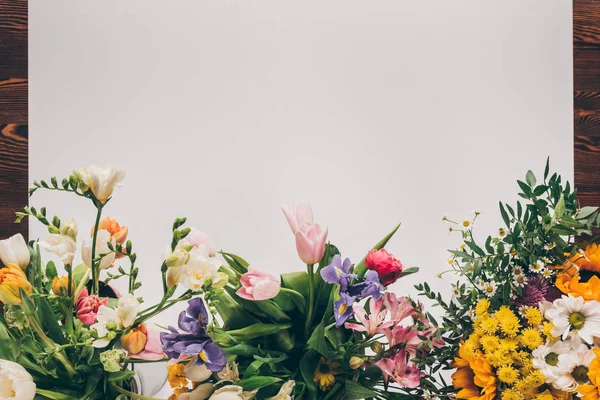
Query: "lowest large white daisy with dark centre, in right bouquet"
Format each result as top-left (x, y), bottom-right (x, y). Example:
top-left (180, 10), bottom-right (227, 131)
top-left (552, 344), bottom-right (596, 392)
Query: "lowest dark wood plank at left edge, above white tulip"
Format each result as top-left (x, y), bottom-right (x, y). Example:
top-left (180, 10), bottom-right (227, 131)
top-left (0, 124), bottom-right (28, 238)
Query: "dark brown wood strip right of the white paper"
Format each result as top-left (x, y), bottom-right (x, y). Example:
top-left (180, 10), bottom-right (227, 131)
top-left (573, 0), bottom-right (600, 206)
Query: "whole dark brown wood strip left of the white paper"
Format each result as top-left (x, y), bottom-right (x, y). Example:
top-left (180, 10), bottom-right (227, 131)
top-left (0, 0), bottom-right (28, 239)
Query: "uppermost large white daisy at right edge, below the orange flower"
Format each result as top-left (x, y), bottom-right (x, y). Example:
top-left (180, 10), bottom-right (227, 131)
top-left (544, 295), bottom-right (600, 344)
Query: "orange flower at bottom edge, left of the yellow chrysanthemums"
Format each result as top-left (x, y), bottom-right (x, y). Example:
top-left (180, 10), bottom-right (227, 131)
top-left (452, 346), bottom-right (497, 400)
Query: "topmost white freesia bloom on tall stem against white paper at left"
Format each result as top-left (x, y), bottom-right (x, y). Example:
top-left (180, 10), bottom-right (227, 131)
top-left (74, 165), bottom-right (125, 204)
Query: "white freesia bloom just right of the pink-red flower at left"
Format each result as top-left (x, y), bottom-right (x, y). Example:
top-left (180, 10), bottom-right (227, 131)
top-left (90, 294), bottom-right (140, 348)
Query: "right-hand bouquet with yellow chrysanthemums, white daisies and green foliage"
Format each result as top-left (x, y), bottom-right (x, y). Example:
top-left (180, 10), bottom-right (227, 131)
top-left (417, 163), bottom-right (600, 400)
